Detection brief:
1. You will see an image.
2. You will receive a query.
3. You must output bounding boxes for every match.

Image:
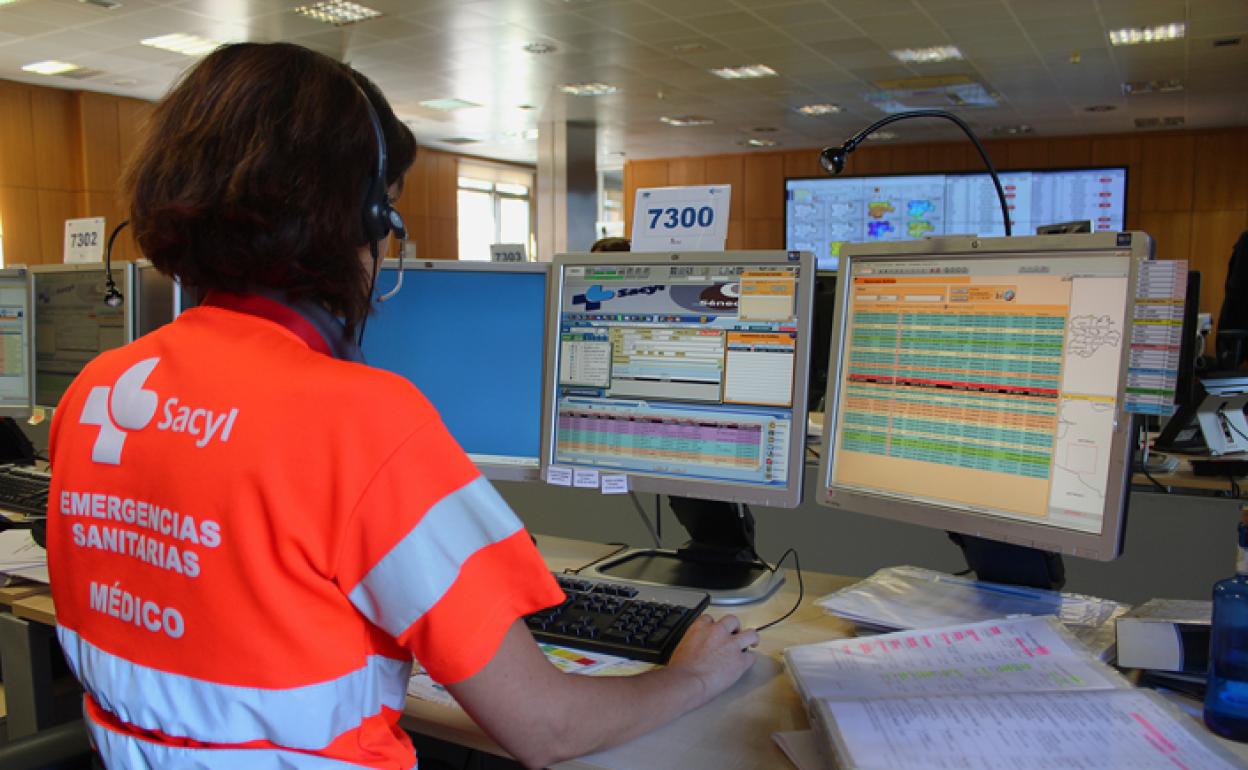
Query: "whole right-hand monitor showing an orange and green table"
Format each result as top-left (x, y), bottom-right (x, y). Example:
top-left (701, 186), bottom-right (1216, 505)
top-left (817, 232), bottom-right (1152, 564)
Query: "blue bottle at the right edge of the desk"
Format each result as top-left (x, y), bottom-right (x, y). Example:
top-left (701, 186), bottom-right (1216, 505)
top-left (1204, 505), bottom-right (1248, 741)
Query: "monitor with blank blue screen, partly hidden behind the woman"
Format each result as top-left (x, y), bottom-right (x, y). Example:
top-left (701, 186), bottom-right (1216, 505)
top-left (363, 260), bottom-right (550, 480)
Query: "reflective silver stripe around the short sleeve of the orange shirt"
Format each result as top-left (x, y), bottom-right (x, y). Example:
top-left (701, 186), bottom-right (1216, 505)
top-left (348, 478), bottom-right (522, 636)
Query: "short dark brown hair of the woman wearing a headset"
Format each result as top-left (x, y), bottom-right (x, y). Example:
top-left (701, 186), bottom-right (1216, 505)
top-left (124, 42), bottom-right (416, 328)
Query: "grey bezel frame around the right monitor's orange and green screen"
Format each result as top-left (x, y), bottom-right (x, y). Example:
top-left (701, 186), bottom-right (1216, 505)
top-left (815, 231), bottom-right (1153, 562)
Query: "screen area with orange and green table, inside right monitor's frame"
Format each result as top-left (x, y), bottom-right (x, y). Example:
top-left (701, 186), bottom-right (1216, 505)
top-left (834, 255), bottom-right (1129, 532)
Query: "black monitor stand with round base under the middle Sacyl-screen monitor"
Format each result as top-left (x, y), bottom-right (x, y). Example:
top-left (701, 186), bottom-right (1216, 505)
top-left (585, 497), bottom-right (784, 605)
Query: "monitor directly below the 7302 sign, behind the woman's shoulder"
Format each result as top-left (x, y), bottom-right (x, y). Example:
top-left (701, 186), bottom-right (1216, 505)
top-left (27, 262), bottom-right (135, 408)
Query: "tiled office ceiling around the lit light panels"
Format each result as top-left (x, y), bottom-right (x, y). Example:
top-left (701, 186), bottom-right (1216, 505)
top-left (0, 0), bottom-right (1248, 166)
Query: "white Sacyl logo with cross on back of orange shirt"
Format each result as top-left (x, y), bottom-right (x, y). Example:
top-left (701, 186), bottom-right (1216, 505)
top-left (79, 358), bottom-right (238, 465)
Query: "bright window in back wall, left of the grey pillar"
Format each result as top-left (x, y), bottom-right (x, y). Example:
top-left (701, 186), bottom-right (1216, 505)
top-left (458, 163), bottom-right (535, 262)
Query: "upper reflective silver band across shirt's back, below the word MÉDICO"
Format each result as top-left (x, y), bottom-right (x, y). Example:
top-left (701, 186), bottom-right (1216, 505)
top-left (56, 626), bottom-right (412, 748)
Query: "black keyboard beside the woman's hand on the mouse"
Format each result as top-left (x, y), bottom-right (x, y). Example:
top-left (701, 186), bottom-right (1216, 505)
top-left (524, 574), bottom-right (710, 663)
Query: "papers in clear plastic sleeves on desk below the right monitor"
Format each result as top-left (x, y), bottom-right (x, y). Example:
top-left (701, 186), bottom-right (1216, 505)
top-left (819, 567), bottom-right (1131, 660)
